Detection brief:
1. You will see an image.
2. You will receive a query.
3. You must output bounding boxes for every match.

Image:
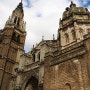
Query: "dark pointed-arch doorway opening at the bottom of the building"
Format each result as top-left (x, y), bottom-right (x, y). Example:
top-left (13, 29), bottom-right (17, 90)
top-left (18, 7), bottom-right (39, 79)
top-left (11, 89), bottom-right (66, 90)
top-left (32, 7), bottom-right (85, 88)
top-left (25, 77), bottom-right (38, 90)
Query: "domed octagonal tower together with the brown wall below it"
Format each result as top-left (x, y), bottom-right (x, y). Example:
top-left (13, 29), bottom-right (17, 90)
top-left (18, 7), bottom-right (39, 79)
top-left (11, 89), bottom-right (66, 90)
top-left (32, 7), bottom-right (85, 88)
top-left (44, 2), bottom-right (90, 90)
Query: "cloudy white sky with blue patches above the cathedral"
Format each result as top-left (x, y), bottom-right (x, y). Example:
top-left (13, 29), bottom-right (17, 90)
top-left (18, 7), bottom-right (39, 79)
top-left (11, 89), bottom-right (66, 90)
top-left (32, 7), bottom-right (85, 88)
top-left (0, 0), bottom-right (90, 52)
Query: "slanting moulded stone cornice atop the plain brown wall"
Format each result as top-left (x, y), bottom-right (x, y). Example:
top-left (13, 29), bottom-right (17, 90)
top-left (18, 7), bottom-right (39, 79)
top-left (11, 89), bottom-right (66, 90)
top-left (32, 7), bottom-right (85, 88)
top-left (51, 42), bottom-right (86, 66)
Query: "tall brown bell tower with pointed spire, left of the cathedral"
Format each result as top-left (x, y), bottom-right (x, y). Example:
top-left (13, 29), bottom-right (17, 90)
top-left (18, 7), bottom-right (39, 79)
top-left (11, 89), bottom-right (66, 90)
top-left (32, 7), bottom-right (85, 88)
top-left (0, 1), bottom-right (26, 90)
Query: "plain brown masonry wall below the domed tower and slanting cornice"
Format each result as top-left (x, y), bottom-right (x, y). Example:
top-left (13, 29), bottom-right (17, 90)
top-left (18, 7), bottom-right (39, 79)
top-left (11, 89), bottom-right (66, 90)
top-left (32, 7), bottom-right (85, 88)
top-left (44, 38), bottom-right (90, 90)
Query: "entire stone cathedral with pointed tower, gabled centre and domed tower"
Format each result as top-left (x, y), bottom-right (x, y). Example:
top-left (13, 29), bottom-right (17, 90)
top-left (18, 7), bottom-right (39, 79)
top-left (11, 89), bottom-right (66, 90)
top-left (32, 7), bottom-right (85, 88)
top-left (0, 2), bottom-right (90, 90)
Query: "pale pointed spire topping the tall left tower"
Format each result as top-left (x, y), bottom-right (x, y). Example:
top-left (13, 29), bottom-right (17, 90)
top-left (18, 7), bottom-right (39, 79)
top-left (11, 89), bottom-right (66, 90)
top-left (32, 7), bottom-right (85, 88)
top-left (5, 0), bottom-right (26, 31)
